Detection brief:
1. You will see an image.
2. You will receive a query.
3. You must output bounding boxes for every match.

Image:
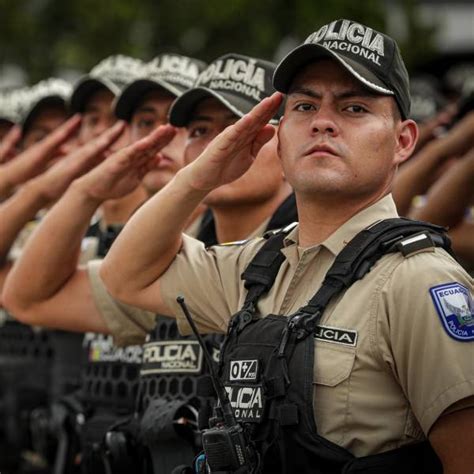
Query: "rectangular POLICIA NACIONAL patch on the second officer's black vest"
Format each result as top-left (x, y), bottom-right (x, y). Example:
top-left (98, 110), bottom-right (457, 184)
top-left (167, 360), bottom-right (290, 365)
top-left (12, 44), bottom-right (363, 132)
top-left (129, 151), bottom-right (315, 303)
top-left (140, 341), bottom-right (203, 375)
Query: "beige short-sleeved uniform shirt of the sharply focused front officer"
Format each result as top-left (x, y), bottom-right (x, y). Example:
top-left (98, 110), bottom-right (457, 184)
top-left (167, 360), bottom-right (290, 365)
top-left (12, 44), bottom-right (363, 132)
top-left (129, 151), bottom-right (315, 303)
top-left (161, 196), bottom-right (474, 456)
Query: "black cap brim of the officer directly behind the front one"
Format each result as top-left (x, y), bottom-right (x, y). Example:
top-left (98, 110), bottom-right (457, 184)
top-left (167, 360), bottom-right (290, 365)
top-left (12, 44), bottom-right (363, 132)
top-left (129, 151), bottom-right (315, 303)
top-left (170, 87), bottom-right (268, 127)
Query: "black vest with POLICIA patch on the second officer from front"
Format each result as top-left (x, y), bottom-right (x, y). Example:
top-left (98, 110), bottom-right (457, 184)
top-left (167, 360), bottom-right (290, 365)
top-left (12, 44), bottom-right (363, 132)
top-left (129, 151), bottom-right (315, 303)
top-left (119, 315), bottom-right (223, 473)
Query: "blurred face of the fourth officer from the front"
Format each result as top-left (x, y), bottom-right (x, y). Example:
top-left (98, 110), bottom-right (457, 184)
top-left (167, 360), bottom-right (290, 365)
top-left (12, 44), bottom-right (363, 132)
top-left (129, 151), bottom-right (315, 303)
top-left (79, 88), bottom-right (116, 145)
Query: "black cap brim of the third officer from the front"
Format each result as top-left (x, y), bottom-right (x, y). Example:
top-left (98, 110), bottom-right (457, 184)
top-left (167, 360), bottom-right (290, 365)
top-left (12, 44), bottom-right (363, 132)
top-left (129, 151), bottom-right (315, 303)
top-left (114, 79), bottom-right (184, 122)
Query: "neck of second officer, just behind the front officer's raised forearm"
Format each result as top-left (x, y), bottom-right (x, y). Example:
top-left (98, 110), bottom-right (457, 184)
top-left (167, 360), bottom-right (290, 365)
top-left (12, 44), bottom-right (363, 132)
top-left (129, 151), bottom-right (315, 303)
top-left (210, 183), bottom-right (292, 243)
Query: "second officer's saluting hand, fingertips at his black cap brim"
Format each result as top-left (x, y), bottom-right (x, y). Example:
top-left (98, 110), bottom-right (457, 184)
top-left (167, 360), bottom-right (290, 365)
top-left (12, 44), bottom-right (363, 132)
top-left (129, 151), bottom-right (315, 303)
top-left (76, 125), bottom-right (176, 202)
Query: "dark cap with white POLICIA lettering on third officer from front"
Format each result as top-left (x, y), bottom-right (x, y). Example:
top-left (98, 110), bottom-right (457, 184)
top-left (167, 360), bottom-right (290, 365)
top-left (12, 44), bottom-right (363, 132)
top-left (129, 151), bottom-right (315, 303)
top-left (115, 54), bottom-right (206, 121)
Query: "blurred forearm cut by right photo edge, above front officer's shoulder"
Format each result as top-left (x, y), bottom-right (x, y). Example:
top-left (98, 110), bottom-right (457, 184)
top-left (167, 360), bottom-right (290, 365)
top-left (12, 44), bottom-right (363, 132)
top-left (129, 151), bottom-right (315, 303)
top-left (411, 152), bottom-right (474, 227)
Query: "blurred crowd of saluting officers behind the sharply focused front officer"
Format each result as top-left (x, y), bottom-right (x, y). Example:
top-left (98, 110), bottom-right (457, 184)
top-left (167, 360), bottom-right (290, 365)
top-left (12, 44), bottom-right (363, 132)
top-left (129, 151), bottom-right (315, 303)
top-left (0, 45), bottom-right (474, 474)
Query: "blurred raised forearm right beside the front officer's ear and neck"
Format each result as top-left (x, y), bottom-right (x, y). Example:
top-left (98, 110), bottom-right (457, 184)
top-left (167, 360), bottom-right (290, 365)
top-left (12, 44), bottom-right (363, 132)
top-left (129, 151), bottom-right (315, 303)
top-left (393, 139), bottom-right (448, 216)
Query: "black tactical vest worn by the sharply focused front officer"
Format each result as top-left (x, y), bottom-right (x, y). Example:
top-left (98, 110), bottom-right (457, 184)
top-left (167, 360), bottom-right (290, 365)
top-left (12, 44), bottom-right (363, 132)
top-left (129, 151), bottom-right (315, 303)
top-left (213, 218), bottom-right (450, 474)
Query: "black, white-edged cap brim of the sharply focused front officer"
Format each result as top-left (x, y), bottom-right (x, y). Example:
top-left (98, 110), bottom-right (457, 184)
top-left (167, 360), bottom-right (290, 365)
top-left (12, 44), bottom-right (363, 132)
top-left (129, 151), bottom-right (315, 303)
top-left (273, 43), bottom-right (395, 95)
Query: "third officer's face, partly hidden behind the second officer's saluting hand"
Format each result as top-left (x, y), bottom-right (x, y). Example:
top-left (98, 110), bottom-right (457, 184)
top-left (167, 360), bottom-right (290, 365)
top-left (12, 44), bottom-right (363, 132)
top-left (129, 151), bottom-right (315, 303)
top-left (130, 89), bottom-right (187, 194)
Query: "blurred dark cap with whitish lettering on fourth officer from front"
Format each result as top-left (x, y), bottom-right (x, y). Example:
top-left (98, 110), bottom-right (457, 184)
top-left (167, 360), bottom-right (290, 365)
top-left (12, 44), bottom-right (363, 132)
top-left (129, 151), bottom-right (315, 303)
top-left (71, 54), bottom-right (143, 112)
